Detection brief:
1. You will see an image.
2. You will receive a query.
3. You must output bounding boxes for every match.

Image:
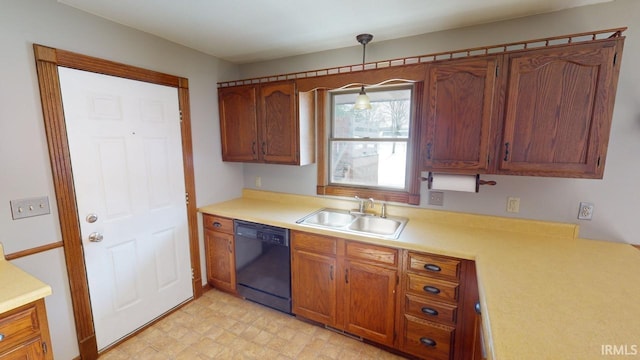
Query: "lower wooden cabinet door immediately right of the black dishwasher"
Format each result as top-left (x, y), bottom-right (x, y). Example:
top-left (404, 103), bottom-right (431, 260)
top-left (291, 250), bottom-right (337, 326)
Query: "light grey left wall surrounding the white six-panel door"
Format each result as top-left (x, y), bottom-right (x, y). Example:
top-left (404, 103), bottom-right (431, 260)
top-left (0, 0), bottom-right (243, 360)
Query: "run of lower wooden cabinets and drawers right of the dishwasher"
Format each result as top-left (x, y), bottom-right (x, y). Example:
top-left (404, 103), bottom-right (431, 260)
top-left (291, 231), bottom-right (478, 360)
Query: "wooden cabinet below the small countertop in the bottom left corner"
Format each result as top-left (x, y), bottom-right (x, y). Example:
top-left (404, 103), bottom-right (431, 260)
top-left (0, 299), bottom-right (53, 360)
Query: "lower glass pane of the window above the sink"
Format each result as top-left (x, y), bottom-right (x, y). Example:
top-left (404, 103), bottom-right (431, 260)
top-left (329, 141), bottom-right (407, 189)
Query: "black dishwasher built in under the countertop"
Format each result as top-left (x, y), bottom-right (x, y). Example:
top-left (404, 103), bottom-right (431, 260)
top-left (233, 220), bottom-right (291, 314)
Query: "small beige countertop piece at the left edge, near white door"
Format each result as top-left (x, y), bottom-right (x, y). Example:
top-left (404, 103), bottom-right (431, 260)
top-left (0, 244), bottom-right (51, 314)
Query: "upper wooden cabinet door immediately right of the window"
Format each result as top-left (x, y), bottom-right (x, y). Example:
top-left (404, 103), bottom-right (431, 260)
top-left (421, 56), bottom-right (498, 174)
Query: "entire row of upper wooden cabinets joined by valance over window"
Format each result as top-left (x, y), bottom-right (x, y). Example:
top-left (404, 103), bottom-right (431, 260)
top-left (219, 28), bottom-right (626, 179)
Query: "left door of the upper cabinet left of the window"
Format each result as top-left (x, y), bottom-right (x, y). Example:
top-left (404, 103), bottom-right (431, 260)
top-left (218, 86), bottom-right (259, 162)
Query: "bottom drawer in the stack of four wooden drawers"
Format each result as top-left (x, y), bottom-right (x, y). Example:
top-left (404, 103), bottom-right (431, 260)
top-left (401, 315), bottom-right (455, 360)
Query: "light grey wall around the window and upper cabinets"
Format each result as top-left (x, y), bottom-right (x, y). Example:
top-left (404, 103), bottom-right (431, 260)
top-left (240, 0), bottom-right (640, 244)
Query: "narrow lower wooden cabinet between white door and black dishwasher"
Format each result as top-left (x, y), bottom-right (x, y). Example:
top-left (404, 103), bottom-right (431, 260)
top-left (202, 214), bottom-right (236, 293)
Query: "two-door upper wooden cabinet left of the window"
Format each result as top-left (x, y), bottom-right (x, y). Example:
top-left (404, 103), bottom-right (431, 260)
top-left (218, 81), bottom-right (315, 165)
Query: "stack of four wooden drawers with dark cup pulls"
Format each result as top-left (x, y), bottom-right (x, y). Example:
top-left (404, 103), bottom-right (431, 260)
top-left (399, 250), bottom-right (478, 360)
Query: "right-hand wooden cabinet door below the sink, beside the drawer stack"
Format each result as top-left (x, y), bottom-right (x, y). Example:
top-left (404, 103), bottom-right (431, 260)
top-left (344, 260), bottom-right (398, 346)
